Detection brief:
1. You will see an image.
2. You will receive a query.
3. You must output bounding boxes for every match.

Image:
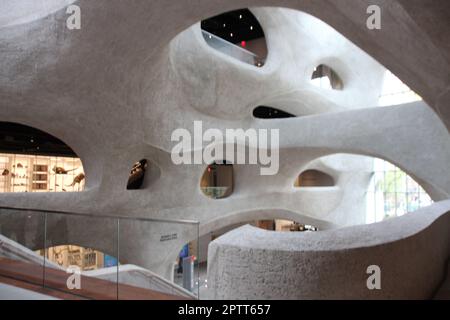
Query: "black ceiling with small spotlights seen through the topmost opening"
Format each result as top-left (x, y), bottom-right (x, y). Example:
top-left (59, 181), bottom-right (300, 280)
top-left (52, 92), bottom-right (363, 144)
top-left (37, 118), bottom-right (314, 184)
top-left (201, 9), bottom-right (264, 43)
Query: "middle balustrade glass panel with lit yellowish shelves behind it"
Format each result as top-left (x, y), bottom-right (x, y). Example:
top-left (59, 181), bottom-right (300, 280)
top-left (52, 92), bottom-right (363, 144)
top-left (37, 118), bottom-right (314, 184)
top-left (44, 213), bottom-right (118, 300)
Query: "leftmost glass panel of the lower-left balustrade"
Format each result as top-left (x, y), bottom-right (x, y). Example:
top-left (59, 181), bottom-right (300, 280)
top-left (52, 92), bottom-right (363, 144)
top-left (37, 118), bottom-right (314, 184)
top-left (0, 209), bottom-right (45, 285)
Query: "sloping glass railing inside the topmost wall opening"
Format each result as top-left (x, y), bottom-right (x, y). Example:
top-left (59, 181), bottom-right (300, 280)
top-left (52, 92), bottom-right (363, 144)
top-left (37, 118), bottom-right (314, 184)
top-left (202, 30), bottom-right (265, 67)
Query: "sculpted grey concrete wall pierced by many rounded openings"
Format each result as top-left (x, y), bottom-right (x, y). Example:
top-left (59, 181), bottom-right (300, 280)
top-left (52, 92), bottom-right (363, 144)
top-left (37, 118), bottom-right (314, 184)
top-left (0, 0), bottom-right (450, 279)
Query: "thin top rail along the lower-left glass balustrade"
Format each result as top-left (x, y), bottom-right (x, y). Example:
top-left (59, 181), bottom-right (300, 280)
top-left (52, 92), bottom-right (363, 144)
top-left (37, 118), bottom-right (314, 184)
top-left (0, 206), bottom-right (200, 225)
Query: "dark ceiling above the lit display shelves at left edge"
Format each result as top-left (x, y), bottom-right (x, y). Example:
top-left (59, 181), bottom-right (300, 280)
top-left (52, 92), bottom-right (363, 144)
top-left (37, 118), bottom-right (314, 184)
top-left (0, 122), bottom-right (77, 157)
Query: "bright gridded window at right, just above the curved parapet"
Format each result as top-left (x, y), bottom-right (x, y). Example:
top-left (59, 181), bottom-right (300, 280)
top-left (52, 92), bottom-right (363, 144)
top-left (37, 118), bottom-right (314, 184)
top-left (366, 158), bottom-right (433, 223)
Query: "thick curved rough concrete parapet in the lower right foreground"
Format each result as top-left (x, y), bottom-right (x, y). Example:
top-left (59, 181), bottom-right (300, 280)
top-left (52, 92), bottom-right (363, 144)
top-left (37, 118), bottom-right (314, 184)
top-left (208, 200), bottom-right (450, 299)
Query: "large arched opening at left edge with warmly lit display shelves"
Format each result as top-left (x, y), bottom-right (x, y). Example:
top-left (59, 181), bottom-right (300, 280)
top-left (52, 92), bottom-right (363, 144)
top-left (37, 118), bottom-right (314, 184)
top-left (0, 122), bottom-right (86, 193)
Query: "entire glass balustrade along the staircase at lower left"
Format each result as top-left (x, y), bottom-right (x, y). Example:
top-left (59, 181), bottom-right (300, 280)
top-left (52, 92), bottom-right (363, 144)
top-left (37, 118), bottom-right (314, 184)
top-left (0, 207), bottom-right (200, 300)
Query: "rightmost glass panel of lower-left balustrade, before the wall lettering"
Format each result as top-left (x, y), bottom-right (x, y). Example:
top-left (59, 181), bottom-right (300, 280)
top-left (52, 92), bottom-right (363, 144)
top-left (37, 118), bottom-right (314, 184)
top-left (119, 219), bottom-right (199, 300)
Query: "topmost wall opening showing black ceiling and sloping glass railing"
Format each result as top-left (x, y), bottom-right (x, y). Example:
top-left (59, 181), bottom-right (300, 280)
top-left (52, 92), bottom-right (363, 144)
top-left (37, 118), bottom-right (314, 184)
top-left (201, 9), bottom-right (267, 67)
